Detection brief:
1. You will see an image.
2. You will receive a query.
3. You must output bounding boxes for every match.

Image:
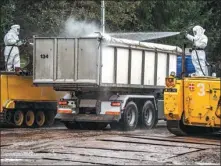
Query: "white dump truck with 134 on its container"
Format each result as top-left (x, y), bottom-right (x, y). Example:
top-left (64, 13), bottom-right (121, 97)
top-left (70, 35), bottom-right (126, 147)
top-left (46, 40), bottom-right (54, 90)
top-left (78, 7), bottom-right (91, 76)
top-left (33, 34), bottom-right (182, 130)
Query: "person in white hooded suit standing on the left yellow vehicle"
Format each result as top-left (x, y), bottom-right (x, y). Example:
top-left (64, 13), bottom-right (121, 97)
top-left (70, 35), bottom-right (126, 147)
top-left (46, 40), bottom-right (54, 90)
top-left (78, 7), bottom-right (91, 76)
top-left (4, 25), bottom-right (23, 71)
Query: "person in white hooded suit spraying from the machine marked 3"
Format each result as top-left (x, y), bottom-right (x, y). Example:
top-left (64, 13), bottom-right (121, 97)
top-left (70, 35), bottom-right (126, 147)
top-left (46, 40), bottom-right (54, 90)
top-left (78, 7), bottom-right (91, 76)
top-left (186, 25), bottom-right (208, 76)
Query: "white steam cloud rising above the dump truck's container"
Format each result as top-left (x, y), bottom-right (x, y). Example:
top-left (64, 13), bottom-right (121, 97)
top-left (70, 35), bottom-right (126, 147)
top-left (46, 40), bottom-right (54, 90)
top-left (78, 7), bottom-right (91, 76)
top-left (61, 17), bottom-right (100, 37)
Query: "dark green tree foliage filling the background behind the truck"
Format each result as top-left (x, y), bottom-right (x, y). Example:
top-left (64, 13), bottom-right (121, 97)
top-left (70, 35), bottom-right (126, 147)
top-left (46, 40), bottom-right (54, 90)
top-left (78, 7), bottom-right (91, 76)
top-left (0, 0), bottom-right (221, 60)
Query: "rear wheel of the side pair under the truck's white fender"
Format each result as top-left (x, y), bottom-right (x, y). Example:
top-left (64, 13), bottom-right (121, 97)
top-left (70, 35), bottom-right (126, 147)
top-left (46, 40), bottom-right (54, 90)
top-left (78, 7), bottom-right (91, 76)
top-left (120, 101), bottom-right (138, 131)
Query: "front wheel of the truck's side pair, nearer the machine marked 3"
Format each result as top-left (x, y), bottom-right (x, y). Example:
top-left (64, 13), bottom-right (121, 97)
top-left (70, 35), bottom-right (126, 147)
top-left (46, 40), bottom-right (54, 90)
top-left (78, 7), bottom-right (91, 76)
top-left (141, 101), bottom-right (158, 129)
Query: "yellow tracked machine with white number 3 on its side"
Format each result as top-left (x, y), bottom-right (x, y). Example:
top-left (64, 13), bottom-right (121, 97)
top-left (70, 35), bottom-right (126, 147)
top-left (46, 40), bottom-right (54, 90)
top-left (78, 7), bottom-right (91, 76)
top-left (164, 76), bottom-right (221, 136)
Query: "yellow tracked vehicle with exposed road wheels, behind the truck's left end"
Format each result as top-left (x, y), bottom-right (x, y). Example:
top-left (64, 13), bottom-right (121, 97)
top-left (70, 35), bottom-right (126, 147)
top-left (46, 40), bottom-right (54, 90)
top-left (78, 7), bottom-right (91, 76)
top-left (0, 43), bottom-right (64, 127)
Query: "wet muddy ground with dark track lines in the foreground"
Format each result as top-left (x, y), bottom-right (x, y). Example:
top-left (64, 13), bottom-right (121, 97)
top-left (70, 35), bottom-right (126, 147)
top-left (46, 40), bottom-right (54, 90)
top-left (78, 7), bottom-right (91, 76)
top-left (1, 121), bottom-right (221, 165)
